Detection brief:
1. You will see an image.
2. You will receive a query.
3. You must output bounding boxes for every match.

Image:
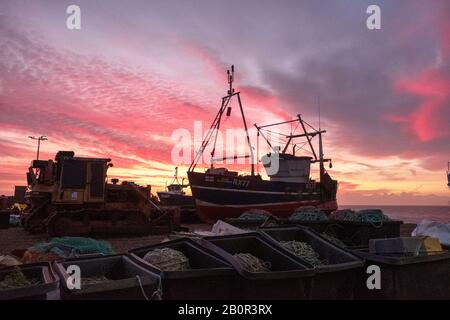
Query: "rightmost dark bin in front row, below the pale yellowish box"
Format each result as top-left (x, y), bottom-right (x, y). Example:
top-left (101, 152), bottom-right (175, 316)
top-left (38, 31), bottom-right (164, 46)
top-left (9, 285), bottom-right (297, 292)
top-left (353, 249), bottom-right (450, 300)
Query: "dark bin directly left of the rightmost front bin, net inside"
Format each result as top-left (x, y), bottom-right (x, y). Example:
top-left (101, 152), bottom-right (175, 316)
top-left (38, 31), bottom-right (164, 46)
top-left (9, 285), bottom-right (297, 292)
top-left (260, 226), bottom-right (364, 300)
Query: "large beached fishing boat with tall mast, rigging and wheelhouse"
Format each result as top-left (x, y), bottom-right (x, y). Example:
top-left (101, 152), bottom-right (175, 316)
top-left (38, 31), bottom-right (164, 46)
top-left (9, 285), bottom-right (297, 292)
top-left (187, 66), bottom-right (338, 222)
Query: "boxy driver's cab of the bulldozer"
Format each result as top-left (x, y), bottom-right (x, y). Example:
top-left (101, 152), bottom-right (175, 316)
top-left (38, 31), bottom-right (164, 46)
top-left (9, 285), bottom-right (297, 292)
top-left (54, 157), bottom-right (111, 203)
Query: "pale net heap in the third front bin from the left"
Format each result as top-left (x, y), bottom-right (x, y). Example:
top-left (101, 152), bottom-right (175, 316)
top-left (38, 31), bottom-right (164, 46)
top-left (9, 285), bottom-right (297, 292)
top-left (144, 248), bottom-right (191, 271)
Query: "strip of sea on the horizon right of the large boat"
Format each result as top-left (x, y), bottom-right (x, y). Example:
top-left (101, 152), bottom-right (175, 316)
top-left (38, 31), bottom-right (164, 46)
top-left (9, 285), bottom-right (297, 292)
top-left (339, 205), bottom-right (450, 223)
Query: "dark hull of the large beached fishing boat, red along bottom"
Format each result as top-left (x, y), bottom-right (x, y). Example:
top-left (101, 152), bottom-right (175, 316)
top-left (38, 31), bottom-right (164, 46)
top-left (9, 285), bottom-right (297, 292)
top-left (188, 172), bottom-right (337, 223)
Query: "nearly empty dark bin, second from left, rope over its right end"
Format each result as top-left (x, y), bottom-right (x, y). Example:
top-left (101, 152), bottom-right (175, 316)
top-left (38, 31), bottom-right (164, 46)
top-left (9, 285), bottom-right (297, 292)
top-left (54, 254), bottom-right (161, 300)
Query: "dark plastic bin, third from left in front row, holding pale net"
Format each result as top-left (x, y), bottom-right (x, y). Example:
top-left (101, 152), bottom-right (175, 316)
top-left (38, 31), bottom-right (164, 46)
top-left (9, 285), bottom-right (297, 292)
top-left (129, 238), bottom-right (237, 300)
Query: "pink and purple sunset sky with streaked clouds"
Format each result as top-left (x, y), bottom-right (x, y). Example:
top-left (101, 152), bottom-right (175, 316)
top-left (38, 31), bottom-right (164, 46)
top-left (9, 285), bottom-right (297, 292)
top-left (0, 0), bottom-right (450, 205)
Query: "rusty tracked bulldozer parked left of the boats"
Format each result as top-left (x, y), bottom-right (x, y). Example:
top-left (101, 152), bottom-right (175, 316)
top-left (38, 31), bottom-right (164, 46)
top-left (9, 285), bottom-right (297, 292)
top-left (21, 151), bottom-right (179, 236)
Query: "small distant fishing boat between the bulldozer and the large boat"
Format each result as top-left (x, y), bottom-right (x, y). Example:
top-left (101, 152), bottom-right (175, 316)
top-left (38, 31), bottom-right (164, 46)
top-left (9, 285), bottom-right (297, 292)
top-left (157, 167), bottom-right (195, 209)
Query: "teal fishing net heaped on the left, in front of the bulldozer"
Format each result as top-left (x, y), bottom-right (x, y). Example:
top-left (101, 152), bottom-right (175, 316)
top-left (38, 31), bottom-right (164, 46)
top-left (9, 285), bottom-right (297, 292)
top-left (28, 237), bottom-right (114, 258)
